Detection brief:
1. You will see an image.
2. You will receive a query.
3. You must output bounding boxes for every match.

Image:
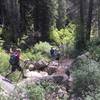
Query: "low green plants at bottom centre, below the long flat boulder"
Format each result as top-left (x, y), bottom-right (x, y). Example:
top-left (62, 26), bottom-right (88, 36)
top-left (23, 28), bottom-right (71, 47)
top-left (26, 81), bottom-right (58, 100)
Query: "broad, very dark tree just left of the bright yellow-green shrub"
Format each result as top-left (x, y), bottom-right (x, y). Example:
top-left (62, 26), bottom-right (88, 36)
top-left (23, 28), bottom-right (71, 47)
top-left (33, 0), bottom-right (55, 41)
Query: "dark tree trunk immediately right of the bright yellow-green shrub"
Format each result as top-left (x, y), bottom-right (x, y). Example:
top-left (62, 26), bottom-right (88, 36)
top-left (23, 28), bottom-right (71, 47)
top-left (76, 0), bottom-right (86, 53)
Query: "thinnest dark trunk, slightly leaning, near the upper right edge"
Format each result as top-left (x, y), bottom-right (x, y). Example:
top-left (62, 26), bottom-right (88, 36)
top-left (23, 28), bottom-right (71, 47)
top-left (86, 0), bottom-right (94, 42)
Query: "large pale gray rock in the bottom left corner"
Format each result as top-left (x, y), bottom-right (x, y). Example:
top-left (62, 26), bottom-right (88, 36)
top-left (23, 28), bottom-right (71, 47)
top-left (0, 76), bottom-right (29, 100)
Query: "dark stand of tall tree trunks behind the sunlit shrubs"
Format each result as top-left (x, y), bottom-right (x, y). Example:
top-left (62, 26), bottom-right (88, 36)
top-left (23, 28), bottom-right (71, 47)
top-left (0, 0), bottom-right (100, 51)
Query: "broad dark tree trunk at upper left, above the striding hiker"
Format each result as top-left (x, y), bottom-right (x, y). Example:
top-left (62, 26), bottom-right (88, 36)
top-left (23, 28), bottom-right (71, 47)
top-left (4, 0), bottom-right (20, 43)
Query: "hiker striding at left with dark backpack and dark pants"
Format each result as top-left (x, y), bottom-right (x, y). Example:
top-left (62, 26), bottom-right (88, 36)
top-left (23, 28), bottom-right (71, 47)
top-left (5, 47), bottom-right (25, 78)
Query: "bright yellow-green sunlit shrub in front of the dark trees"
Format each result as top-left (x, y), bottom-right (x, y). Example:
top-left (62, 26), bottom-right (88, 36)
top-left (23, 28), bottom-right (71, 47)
top-left (50, 23), bottom-right (76, 56)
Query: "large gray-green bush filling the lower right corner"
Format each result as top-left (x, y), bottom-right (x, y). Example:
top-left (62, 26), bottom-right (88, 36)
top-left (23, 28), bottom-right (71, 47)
top-left (72, 59), bottom-right (100, 100)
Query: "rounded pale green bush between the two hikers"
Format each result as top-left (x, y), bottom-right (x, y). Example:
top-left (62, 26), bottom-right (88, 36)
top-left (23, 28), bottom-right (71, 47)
top-left (25, 42), bottom-right (51, 60)
